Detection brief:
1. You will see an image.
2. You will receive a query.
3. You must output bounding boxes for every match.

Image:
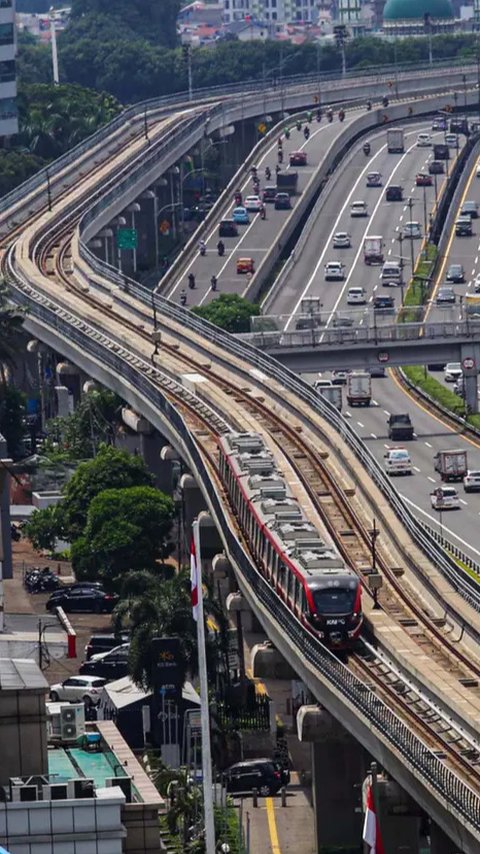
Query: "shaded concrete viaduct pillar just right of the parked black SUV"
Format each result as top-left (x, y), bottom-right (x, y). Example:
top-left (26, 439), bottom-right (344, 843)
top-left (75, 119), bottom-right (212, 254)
top-left (297, 706), bottom-right (370, 854)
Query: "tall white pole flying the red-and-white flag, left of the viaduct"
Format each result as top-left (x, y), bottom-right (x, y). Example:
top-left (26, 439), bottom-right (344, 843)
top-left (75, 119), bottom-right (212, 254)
top-left (192, 519), bottom-right (215, 854)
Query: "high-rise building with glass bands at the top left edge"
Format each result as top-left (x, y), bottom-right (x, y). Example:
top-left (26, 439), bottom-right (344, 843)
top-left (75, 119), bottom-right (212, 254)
top-left (0, 0), bottom-right (18, 137)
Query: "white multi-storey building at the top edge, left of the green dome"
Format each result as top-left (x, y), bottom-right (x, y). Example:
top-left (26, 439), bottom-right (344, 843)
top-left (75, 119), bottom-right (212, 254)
top-left (223, 0), bottom-right (318, 25)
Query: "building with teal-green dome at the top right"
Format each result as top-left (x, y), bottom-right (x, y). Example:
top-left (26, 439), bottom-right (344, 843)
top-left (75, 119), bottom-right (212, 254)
top-left (383, 0), bottom-right (455, 36)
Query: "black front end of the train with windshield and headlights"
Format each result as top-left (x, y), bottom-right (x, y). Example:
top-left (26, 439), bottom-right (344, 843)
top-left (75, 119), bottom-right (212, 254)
top-left (307, 568), bottom-right (363, 650)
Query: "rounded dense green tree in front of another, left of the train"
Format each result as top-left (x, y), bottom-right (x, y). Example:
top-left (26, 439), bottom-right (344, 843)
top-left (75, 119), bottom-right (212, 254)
top-left (72, 486), bottom-right (174, 587)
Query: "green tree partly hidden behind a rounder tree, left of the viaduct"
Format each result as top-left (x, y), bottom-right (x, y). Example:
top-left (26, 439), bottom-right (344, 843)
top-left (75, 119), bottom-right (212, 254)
top-left (59, 445), bottom-right (153, 542)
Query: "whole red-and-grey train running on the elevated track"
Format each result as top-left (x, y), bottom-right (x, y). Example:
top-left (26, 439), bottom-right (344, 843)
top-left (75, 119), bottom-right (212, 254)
top-left (219, 433), bottom-right (363, 650)
